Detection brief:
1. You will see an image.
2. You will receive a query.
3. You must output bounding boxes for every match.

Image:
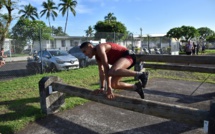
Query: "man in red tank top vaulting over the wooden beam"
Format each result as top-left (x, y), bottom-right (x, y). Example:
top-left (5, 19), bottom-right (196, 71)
top-left (80, 42), bottom-right (148, 99)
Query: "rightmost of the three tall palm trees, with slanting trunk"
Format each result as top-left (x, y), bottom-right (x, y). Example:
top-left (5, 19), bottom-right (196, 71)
top-left (59, 0), bottom-right (77, 33)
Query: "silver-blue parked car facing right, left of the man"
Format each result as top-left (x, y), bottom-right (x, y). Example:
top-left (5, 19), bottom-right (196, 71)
top-left (38, 49), bottom-right (79, 72)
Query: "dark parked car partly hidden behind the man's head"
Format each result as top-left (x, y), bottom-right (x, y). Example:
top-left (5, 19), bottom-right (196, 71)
top-left (68, 46), bottom-right (96, 68)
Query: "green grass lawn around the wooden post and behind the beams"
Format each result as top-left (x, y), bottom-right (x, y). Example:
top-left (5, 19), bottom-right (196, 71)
top-left (0, 65), bottom-right (215, 134)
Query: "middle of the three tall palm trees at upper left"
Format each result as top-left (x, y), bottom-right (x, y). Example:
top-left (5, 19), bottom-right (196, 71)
top-left (40, 0), bottom-right (58, 28)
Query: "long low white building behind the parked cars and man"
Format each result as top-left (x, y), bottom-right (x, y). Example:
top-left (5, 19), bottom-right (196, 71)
top-left (33, 34), bottom-right (179, 55)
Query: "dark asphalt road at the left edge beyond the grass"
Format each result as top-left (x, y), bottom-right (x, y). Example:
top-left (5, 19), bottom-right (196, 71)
top-left (0, 61), bottom-right (29, 81)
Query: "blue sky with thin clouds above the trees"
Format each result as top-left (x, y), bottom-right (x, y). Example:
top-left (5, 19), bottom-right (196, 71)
top-left (1, 0), bottom-right (215, 36)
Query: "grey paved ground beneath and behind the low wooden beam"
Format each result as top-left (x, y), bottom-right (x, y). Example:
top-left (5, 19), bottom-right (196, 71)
top-left (17, 79), bottom-right (215, 134)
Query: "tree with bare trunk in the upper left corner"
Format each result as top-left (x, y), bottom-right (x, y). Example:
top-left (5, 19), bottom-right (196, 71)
top-left (0, 0), bottom-right (17, 47)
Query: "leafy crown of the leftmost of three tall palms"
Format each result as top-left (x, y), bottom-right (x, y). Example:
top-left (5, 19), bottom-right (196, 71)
top-left (18, 4), bottom-right (39, 20)
